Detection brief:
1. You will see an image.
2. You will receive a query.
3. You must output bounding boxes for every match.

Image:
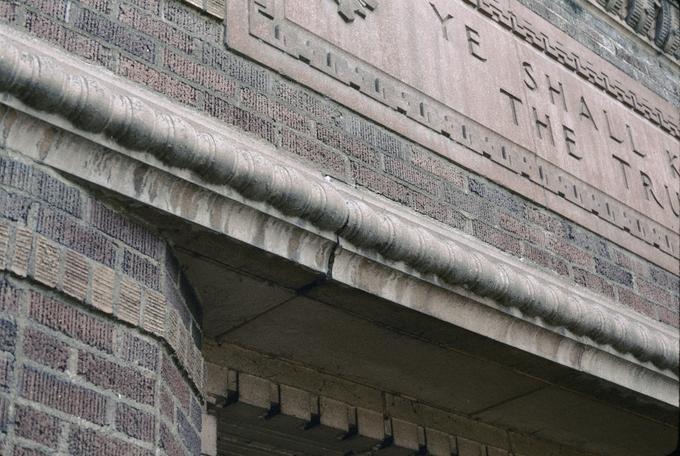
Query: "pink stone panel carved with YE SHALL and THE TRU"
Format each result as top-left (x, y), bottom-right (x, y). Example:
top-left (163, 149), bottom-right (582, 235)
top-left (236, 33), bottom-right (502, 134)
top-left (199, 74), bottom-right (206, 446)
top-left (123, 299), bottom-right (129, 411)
top-left (227, 0), bottom-right (680, 268)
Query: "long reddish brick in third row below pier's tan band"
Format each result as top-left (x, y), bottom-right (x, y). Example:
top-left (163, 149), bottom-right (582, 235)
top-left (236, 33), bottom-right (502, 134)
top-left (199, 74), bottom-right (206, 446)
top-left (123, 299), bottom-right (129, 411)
top-left (21, 368), bottom-right (106, 424)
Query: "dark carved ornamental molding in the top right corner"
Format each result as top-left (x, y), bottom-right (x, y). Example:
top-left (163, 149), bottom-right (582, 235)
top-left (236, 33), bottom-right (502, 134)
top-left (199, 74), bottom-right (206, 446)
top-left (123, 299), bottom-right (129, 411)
top-left (588, 0), bottom-right (680, 58)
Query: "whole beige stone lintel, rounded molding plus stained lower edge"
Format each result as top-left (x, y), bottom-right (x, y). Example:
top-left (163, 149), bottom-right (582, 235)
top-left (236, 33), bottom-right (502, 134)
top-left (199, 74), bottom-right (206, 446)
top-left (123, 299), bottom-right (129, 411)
top-left (0, 28), bottom-right (679, 406)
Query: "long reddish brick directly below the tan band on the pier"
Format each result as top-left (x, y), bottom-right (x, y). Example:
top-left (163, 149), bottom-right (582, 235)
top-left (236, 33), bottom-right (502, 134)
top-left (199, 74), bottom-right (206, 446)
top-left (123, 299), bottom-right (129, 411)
top-left (29, 291), bottom-right (113, 353)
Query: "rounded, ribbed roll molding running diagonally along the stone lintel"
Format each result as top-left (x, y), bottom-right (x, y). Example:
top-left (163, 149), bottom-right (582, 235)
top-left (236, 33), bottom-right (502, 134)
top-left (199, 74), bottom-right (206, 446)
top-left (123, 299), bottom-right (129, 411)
top-left (0, 30), bottom-right (680, 376)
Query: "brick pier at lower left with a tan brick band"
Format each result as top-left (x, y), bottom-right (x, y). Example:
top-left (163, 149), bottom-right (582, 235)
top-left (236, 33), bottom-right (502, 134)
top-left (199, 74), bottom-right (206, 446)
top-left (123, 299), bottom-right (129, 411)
top-left (0, 154), bottom-right (203, 456)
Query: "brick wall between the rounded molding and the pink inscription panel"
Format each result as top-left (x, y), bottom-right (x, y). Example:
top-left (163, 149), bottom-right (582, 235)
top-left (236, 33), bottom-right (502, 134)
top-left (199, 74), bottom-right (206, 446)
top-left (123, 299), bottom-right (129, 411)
top-left (0, 0), bottom-right (680, 327)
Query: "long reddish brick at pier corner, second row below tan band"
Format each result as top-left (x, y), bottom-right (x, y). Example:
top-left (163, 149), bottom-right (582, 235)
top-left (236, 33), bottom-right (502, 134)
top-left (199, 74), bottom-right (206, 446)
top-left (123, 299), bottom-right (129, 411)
top-left (78, 352), bottom-right (155, 405)
